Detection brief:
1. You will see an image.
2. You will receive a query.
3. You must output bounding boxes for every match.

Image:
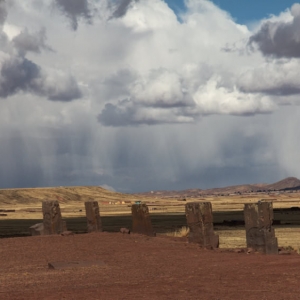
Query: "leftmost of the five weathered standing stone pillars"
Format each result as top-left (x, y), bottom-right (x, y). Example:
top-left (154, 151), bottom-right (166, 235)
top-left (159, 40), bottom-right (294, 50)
top-left (42, 200), bottom-right (66, 235)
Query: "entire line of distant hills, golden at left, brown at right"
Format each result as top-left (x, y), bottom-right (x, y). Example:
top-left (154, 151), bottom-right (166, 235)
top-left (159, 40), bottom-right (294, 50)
top-left (0, 177), bottom-right (300, 205)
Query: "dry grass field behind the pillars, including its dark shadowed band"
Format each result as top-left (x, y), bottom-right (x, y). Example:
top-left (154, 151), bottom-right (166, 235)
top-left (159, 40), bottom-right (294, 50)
top-left (0, 187), bottom-right (300, 249)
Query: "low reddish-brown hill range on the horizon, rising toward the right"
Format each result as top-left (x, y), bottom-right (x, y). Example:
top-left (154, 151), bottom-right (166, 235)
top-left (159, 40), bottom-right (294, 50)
top-left (137, 177), bottom-right (300, 198)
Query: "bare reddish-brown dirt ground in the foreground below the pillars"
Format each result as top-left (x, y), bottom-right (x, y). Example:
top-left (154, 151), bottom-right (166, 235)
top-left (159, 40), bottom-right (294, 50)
top-left (0, 233), bottom-right (300, 300)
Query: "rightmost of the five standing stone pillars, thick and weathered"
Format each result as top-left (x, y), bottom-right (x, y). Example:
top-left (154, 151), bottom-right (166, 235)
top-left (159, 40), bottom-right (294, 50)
top-left (244, 201), bottom-right (278, 254)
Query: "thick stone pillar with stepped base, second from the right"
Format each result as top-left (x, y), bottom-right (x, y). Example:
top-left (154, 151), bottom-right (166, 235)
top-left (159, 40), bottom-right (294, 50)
top-left (185, 202), bottom-right (219, 248)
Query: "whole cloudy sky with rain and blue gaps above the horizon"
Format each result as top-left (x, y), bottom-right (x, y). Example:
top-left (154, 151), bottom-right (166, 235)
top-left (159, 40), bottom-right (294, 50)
top-left (0, 0), bottom-right (300, 192)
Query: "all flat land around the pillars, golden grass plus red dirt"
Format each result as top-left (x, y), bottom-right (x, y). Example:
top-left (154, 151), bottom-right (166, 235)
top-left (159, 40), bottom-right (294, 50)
top-left (0, 187), bottom-right (300, 300)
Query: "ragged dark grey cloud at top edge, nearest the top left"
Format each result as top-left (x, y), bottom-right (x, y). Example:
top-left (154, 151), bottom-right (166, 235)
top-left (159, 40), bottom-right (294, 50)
top-left (55, 0), bottom-right (92, 30)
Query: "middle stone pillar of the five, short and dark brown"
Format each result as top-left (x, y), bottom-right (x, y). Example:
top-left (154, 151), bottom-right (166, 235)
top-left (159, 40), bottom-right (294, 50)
top-left (131, 204), bottom-right (155, 236)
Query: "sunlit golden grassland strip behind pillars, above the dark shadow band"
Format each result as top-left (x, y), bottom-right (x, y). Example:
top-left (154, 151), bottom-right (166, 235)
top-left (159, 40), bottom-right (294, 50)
top-left (0, 186), bottom-right (300, 219)
